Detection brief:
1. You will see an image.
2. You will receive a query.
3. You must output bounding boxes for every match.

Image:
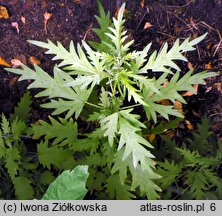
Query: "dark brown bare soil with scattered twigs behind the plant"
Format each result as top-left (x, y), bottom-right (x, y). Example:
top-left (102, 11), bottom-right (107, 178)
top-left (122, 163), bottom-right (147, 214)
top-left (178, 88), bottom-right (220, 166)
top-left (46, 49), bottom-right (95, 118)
top-left (0, 0), bottom-right (222, 136)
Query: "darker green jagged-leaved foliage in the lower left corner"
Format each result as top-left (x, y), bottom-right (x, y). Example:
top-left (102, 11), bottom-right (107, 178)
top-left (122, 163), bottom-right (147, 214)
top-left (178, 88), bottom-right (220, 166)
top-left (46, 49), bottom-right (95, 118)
top-left (0, 92), bottom-right (54, 199)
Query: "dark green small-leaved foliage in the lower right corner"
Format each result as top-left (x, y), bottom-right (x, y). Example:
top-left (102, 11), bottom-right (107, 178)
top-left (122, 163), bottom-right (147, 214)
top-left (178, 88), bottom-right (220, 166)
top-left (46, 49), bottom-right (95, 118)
top-left (154, 117), bottom-right (222, 199)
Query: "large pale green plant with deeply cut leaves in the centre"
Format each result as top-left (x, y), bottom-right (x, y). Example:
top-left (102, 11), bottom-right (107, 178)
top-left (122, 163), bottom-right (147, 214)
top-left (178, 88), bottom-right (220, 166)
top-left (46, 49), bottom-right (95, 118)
top-left (7, 2), bottom-right (219, 199)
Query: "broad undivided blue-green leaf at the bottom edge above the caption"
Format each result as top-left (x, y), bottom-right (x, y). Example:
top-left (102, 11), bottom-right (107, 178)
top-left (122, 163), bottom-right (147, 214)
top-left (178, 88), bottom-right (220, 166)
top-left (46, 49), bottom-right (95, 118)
top-left (42, 166), bottom-right (89, 200)
